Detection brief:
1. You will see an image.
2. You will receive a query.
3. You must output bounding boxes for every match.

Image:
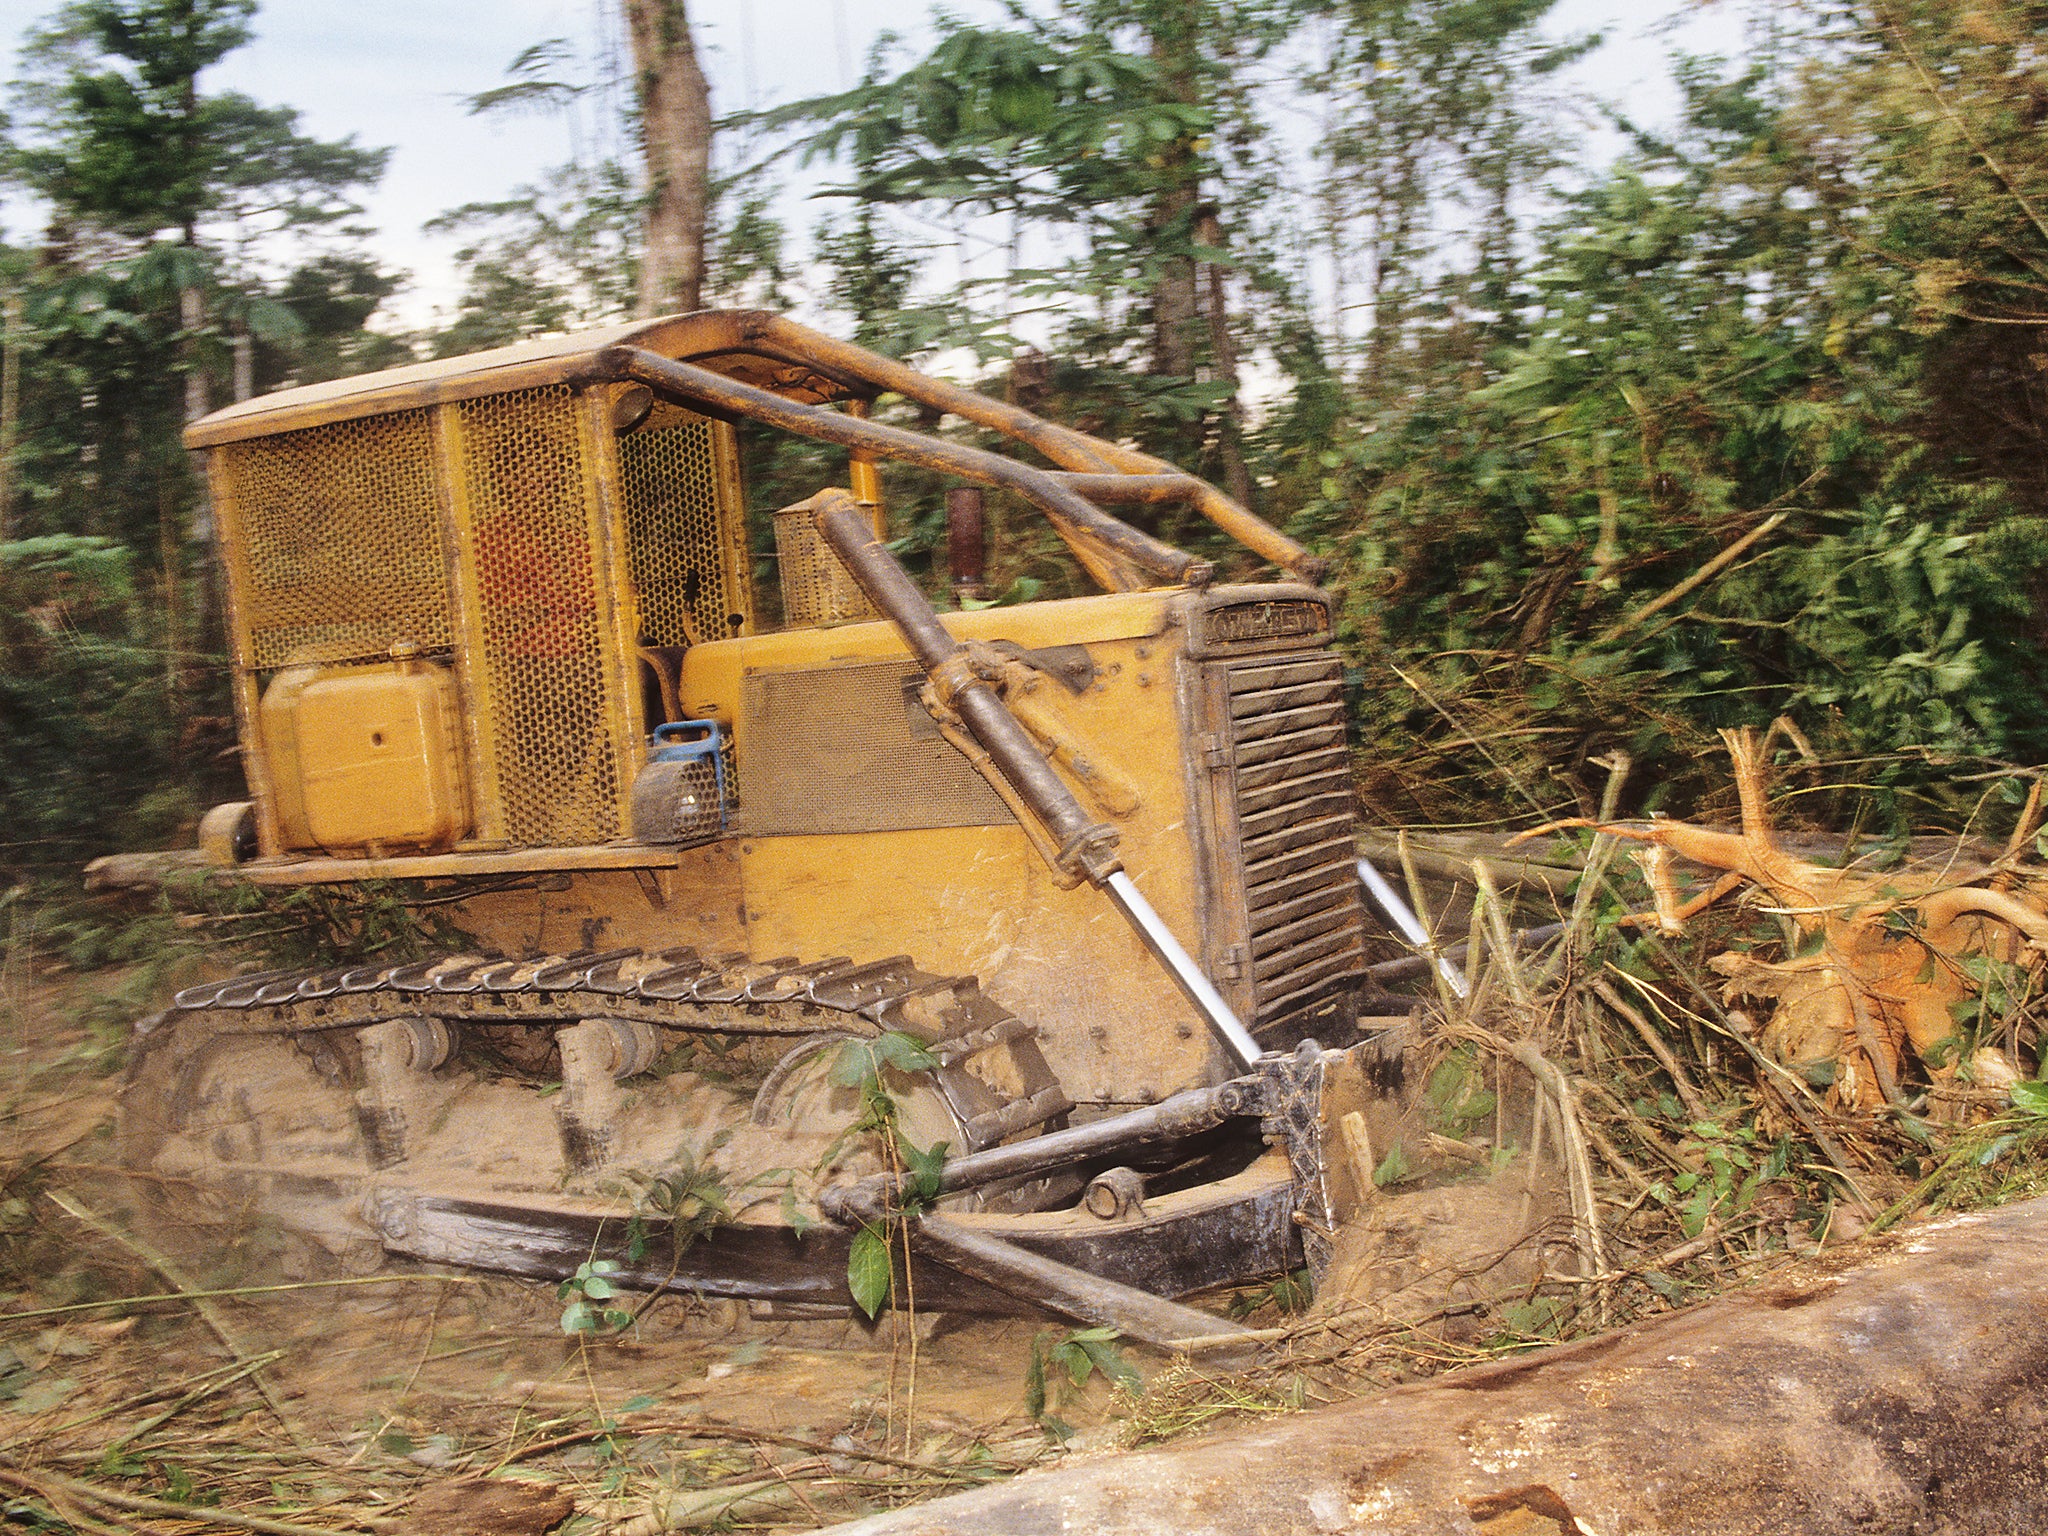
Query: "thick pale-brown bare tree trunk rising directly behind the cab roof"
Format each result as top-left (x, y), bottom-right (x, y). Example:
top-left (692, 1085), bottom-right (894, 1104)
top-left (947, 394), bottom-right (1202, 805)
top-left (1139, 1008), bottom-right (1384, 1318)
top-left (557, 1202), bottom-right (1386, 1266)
top-left (625, 0), bottom-right (711, 315)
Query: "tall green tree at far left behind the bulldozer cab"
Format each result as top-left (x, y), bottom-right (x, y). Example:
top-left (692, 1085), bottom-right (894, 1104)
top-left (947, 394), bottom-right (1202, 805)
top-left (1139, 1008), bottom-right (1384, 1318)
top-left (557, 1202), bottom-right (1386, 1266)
top-left (0, 0), bottom-right (385, 774)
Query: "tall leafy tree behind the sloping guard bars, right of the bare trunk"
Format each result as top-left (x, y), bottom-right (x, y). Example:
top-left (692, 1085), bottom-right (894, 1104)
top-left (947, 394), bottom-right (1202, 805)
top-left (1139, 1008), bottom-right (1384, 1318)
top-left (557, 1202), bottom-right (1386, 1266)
top-left (764, 0), bottom-right (1284, 512)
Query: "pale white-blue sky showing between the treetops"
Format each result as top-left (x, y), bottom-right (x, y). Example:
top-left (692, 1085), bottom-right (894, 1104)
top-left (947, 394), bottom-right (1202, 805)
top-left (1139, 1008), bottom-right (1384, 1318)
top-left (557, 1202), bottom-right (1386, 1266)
top-left (0, 0), bottom-right (1741, 326)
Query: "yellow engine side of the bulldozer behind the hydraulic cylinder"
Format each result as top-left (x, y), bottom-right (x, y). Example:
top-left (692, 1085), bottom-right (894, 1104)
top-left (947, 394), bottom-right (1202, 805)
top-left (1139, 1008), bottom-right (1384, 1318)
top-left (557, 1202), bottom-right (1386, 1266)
top-left (735, 635), bottom-right (1223, 1104)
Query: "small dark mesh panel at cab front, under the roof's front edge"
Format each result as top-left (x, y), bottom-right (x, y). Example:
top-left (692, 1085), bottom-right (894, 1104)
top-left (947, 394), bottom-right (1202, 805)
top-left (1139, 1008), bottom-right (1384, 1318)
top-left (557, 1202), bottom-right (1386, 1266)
top-left (618, 412), bottom-right (750, 645)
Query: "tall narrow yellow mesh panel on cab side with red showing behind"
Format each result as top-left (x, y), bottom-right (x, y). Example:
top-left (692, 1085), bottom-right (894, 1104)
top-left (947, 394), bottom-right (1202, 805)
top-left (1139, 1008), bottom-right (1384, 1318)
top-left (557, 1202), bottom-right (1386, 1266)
top-left (457, 385), bottom-right (621, 846)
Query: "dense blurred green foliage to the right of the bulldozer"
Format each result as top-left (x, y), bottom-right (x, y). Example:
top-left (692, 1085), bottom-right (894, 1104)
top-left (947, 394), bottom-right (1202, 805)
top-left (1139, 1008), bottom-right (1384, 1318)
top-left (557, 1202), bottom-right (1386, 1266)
top-left (1292, 6), bottom-right (2048, 823)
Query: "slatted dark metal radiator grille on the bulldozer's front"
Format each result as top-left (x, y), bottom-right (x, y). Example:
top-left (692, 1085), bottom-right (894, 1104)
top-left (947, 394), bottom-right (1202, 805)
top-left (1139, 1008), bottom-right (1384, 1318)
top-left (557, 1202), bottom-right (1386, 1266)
top-left (1210, 651), bottom-right (1366, 1026)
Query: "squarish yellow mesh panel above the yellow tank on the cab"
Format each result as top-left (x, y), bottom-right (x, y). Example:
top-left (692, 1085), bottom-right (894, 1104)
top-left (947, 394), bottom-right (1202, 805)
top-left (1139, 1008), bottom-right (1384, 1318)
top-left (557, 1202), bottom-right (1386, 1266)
top-left (215, 412), bottom-right (453, 670)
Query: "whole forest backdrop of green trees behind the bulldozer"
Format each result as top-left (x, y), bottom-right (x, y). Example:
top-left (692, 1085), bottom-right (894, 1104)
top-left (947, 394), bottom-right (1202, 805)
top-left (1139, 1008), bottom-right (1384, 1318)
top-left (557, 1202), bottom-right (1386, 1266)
top-left (0, 0), bottom-right (2048, 885)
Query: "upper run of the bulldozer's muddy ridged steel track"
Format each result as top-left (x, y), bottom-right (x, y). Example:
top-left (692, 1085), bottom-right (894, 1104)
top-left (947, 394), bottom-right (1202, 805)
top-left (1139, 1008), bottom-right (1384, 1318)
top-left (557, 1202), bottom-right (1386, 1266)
top-left (141, 948), bottom-right (1073, 1151)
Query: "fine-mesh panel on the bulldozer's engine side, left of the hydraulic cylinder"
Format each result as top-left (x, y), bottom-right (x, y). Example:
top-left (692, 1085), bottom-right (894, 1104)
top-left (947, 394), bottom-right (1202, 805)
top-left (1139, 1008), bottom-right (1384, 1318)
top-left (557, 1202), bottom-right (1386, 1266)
top-left (739, 662), bottom-right (1012, 838)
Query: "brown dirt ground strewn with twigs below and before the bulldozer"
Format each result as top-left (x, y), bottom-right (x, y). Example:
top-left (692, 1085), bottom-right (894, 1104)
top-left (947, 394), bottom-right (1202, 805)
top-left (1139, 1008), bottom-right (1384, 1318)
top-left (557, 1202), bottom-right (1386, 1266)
top-left (0, 958), bottom-right (1695, 1536)
